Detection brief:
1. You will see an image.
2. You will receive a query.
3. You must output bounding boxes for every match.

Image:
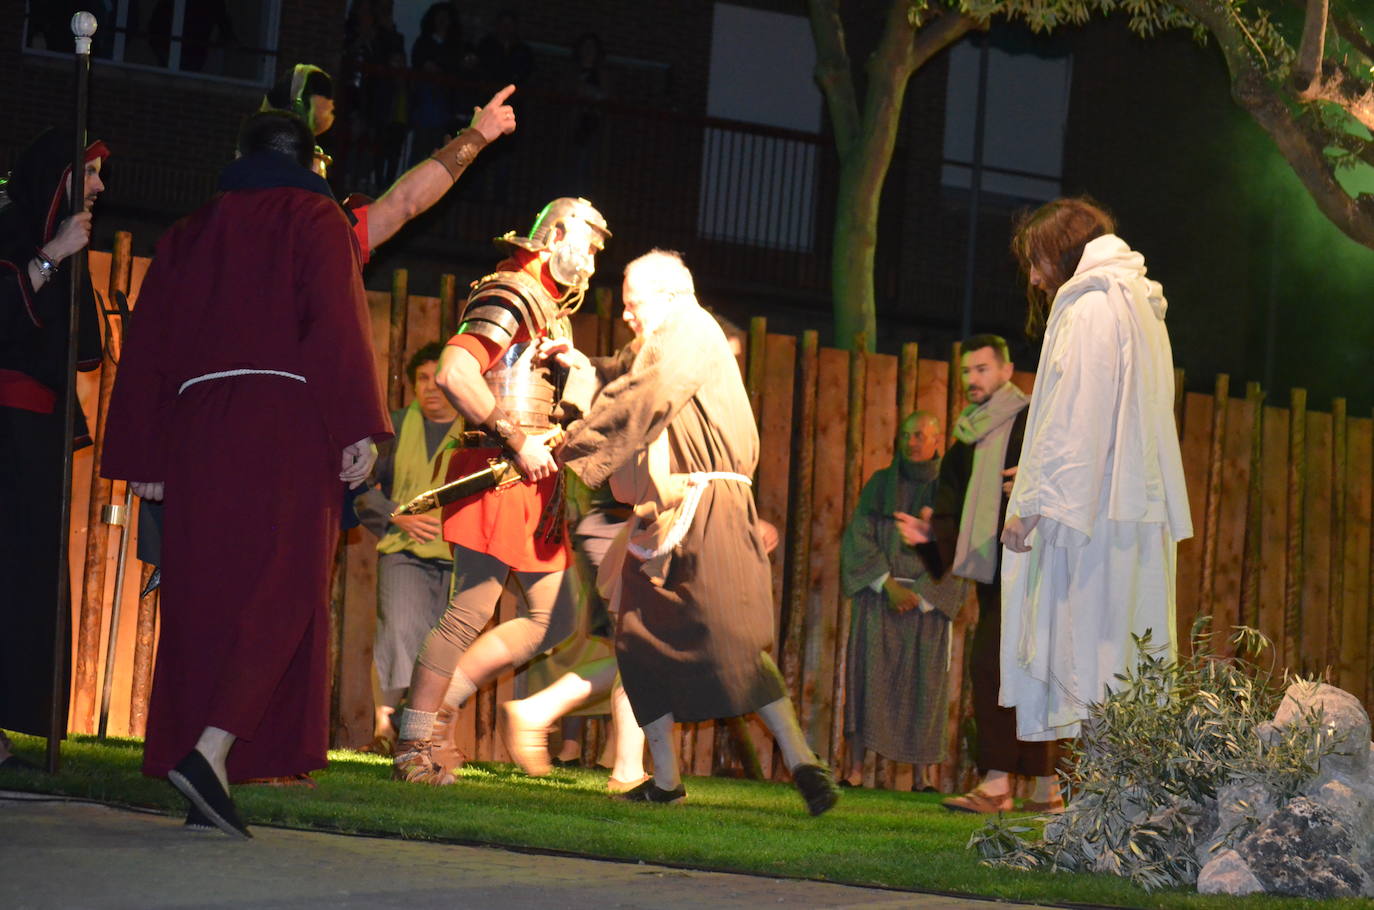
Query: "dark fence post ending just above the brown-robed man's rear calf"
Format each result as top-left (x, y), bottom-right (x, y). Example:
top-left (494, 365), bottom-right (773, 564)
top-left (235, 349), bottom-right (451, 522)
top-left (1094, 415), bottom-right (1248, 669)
top-left (782, 331), bottom-right (819, 711)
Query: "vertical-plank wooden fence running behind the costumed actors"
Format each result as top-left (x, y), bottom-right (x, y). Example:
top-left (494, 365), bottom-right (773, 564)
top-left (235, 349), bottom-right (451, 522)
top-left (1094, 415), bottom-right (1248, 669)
top-left (71, 241), bottom-right (1374, 792)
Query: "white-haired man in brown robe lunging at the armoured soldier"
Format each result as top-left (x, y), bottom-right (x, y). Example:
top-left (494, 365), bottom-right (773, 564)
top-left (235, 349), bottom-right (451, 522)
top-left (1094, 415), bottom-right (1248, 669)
top-left (540, 250), bottom-right (838, 815)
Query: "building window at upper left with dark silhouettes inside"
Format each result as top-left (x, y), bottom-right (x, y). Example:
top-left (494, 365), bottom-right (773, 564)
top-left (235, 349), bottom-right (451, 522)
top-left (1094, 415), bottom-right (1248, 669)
top-left (23, 0), bottom-right (282, 85)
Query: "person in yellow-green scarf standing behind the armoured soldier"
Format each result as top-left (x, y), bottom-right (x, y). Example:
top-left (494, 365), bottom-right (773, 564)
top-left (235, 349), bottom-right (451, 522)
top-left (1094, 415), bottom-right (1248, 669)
top-left (353, 341), bottom-right (458, 752)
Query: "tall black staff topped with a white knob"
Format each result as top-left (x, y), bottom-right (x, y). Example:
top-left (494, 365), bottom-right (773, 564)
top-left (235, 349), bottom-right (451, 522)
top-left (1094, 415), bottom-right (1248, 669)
top-left (47, 12), bottom-right (96, 774)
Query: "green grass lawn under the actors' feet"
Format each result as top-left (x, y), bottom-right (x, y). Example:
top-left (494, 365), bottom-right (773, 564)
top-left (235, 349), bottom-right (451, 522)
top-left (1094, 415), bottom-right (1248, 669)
top-left (0, 737), bottom-right (1370, 910)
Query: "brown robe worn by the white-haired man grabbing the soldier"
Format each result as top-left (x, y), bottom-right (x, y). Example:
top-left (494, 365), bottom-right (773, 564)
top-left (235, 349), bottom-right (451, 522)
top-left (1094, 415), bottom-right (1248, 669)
top-left (562, 302), bottom-right (786, 724)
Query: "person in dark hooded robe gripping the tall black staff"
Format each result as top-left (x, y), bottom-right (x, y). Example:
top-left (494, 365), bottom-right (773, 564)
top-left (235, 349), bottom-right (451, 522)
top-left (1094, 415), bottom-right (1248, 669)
top-left (0, 129), bottom-right (110, 767)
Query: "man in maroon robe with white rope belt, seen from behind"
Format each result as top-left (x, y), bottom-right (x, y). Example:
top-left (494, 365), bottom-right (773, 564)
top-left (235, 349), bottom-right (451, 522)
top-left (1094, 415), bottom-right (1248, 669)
top-left (102, 111), bottom-right (392, 836)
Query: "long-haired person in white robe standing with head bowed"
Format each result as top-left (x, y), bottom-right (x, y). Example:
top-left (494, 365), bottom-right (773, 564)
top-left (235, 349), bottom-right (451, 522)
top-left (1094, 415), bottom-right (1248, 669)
top-left (1000, 198), bottom-right (1193, 742)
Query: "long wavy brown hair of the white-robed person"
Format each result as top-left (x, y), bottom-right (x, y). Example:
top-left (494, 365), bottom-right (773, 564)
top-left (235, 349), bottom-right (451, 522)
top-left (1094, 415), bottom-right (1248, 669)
top-left (1011, 197), bottom-right (1116, 338)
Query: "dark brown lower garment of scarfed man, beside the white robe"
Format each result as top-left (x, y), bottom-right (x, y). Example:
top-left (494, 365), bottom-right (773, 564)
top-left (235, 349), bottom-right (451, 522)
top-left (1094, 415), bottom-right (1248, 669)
top-left (970, 579), bottom-right (1059, 777)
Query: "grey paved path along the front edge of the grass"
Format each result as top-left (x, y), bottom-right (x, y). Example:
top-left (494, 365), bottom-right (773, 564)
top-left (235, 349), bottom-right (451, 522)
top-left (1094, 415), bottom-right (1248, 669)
top-left (0, 792), bottom-right (1049, 910)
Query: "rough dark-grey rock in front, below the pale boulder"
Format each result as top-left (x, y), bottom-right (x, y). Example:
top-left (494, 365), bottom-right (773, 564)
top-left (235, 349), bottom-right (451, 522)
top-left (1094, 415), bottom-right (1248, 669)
top-left (1237, 796), bottom-right (1370, 898)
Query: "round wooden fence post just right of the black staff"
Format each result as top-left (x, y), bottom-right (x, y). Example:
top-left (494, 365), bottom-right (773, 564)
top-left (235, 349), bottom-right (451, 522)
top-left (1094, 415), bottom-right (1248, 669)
top-left (71, 231), bottom-right (133, 733)
